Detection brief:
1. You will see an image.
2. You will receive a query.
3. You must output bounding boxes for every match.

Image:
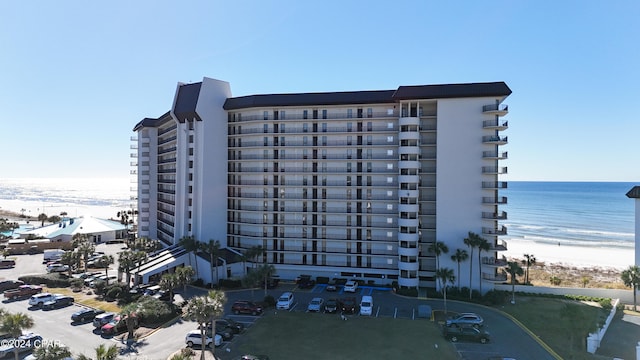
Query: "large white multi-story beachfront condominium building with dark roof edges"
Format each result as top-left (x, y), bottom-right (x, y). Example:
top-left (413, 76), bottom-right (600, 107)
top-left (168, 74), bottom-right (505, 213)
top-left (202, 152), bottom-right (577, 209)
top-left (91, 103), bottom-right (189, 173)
top-left (133, 78), bottom-right (511, 291)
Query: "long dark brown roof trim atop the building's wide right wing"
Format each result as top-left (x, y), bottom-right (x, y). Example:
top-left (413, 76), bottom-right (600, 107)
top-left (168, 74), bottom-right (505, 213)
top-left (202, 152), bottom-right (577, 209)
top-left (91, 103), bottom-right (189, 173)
top-left (224, 82), bottom-right (511, 110)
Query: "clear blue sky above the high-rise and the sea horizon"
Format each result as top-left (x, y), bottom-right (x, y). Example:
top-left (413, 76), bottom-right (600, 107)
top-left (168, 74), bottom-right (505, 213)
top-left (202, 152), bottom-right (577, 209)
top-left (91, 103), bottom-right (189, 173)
top-left (0, 0), bottom-right (640, 182)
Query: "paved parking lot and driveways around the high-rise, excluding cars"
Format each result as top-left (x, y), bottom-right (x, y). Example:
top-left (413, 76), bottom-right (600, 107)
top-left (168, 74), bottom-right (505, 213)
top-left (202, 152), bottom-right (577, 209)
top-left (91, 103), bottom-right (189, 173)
top-left (0, 244), bottom-right (553, 360)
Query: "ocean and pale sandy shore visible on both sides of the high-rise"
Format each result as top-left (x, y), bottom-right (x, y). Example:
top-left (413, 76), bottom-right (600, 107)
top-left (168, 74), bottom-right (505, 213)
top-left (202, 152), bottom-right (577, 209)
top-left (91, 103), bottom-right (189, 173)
top-left (0, 178), bottom-right (637, 268)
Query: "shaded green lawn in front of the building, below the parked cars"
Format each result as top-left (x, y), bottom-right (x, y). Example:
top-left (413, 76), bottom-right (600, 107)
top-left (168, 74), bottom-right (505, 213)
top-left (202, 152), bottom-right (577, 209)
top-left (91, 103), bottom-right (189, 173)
top-left (233, 311), bottom-right (458, 360)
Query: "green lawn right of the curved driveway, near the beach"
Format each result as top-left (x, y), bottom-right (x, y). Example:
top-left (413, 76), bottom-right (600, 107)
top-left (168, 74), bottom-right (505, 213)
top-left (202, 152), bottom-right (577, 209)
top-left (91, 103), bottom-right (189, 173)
top-left (500, 297), bottom-right (607, 360)
